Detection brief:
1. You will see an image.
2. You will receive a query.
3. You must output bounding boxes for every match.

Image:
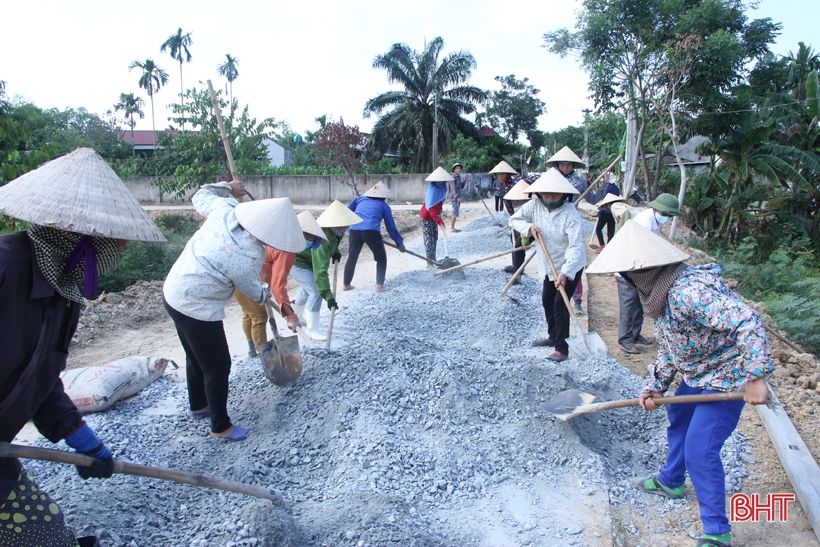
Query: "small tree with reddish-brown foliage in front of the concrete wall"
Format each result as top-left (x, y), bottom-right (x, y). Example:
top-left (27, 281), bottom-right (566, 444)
top-left (313, 116), bottom-right (367, 196)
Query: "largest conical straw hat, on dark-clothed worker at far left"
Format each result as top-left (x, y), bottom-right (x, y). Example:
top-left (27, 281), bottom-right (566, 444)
top-left (0, 148), bottom-right (165, 241)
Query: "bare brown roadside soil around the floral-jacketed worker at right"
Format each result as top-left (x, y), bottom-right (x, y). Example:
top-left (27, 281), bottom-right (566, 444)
top-left (587, 212), bottom-right (820, 547)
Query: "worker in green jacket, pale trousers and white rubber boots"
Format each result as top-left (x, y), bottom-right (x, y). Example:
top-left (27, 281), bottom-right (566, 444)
top-left (290, 200), bottom-right (362, 341)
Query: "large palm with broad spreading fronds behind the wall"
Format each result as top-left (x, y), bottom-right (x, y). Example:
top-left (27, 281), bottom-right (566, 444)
top-left (364, 37), bottom-right (486, 172)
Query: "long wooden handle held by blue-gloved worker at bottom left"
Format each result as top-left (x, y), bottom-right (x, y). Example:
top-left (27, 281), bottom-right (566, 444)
top-left (0, 442), bottom-right (289, 509)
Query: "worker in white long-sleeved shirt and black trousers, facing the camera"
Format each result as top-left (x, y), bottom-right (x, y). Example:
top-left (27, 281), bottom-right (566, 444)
top-left (510, 169), bottom-right (587, 362)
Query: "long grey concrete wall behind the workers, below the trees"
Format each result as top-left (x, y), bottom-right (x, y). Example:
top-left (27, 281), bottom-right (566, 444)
top-left (122, 173), bottom-right (490, 205)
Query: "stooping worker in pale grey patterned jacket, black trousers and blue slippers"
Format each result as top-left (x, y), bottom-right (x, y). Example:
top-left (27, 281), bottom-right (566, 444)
top-left (163, 180), bottom-right (307, 441)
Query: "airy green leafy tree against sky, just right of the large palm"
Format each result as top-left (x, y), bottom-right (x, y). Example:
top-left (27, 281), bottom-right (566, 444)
top-left (487, 74), bottom-right (546, 147)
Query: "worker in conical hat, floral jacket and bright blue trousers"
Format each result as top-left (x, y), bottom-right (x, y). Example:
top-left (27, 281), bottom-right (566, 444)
top-left (587, 219), bottom-right (774, 547)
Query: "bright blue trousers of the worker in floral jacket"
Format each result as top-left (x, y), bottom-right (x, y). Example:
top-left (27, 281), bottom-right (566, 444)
top-left (658, 382), bottom-right (744, 534)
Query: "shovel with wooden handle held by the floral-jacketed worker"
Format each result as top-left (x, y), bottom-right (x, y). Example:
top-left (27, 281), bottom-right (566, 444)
top-left (538, 389), bottom-right (744, 421)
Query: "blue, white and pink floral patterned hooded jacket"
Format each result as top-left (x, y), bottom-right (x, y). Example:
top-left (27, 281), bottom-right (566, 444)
top-left (643, 264), bottom-right (774, 392)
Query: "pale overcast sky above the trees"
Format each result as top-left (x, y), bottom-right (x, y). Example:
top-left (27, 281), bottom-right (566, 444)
top-left (0, 0), bottom-right (820, 137)
